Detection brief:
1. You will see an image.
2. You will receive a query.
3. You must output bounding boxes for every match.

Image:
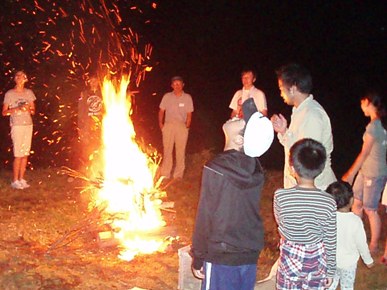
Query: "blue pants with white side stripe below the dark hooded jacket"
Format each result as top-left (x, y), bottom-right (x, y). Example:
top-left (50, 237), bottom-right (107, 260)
top-left (202, 262), bottom-right (257, 290)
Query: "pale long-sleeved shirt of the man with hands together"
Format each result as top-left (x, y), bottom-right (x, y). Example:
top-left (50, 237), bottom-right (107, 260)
top-left (277, 95), bottom-right (336, 190)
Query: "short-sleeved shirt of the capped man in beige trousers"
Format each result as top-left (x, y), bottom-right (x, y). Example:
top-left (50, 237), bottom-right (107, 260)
top-left (159, 92), bottom-right (194, 123)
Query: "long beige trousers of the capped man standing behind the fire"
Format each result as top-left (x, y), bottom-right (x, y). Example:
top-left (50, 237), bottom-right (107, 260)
top-left (161, 123), bottom-right (189, 178)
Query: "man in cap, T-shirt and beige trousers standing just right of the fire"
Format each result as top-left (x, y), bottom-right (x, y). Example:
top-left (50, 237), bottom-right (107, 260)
top-left (158, 76), bottom-right (194, 179)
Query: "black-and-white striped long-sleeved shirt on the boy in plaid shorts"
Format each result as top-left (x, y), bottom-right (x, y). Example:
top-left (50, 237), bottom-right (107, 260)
top-left (273, 186), bottom-right (336, 277)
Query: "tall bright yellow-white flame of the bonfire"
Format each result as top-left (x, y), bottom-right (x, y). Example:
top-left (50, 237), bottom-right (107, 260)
top-left (96, 77), bottom-right (167, 260)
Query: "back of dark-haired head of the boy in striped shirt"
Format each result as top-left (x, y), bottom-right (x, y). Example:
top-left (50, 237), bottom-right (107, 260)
top-left (289, 138), bottom-right (327, 179)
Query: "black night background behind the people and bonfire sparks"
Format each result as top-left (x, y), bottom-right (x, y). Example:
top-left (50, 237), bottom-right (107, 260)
top-left (0, 0), bottom-right (387, 176)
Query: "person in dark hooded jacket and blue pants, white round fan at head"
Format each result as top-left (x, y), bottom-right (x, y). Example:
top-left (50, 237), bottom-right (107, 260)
top-left (191, 99), bottom-right (274, 290)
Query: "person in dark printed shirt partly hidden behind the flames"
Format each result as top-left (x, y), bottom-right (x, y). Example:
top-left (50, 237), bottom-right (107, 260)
top-left (78, 75), bottom-right (103, 162)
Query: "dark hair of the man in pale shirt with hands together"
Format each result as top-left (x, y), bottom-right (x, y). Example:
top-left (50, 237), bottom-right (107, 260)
top-left (276, 63), bottom-right (313, 94)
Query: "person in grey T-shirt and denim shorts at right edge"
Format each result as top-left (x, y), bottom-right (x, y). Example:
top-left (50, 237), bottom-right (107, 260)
top-left (342, 93), bottom-right (387, 253)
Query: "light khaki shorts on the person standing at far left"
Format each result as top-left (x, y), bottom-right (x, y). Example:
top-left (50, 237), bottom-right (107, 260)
top-left (11, 125), bottom-right (32, 157)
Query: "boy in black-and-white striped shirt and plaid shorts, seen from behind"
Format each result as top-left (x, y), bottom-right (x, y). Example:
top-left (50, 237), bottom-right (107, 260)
top-left (273, 139), bottom-right (336, 289)
